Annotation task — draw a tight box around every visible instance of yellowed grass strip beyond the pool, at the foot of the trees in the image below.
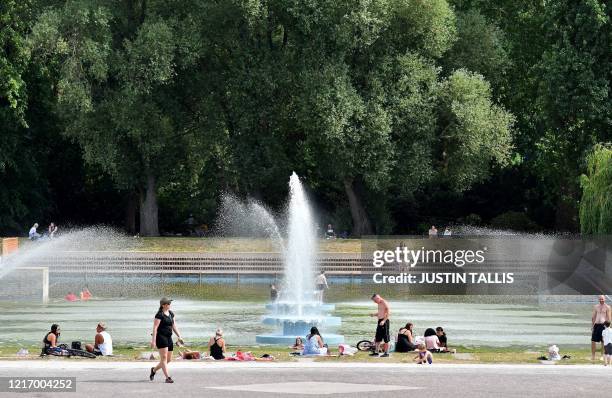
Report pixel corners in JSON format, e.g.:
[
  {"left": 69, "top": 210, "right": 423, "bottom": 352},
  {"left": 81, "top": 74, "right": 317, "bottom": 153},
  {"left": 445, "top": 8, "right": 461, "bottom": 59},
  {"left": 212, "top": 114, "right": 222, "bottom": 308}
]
[{"left": 19, "top": 236, "right": 362, "bottom": 253}]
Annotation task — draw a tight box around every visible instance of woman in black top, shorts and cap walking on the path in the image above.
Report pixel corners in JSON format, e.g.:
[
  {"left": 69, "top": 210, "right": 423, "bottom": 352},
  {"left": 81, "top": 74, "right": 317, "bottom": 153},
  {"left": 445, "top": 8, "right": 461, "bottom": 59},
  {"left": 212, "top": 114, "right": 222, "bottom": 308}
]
[{"left": 149, "top": 297, "right": 183, "bottom": 383}]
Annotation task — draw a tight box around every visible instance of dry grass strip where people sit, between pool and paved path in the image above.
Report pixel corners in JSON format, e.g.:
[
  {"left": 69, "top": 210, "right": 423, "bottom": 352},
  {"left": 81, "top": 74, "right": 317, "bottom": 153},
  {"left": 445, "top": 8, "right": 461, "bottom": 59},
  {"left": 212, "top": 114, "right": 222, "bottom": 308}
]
[{"left": 0, "top": 345, "right": 603, "bottom": 365}]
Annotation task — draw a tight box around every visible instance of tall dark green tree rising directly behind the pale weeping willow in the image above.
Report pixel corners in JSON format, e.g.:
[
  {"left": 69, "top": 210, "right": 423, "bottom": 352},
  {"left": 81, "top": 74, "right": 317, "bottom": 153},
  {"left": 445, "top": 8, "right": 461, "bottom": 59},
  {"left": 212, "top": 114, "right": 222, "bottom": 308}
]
[{"left": 536, "top": 0, "right": 612, "bottom": 230}]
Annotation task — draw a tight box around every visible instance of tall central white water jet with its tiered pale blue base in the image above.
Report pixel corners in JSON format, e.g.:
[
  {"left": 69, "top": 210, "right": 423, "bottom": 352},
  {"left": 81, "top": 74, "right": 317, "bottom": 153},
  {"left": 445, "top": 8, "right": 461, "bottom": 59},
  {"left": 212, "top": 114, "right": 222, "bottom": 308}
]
[{"left": 251, "top": 173, "right": 344, "bottom": 344}]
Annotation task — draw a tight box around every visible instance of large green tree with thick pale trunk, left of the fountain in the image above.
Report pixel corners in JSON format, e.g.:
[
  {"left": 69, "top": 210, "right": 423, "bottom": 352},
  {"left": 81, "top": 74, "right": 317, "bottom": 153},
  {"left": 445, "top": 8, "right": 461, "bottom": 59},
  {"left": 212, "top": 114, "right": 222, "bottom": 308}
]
[{"left": 31, "top": 0, "right": 216, "bottom": 236}]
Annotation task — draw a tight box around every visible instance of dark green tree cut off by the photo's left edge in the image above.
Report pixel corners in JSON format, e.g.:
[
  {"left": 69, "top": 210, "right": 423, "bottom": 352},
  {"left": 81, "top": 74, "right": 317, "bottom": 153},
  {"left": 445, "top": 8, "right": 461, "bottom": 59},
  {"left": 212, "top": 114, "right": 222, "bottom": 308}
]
[{"left": 0, "top": 0, "right": 46, "bottom": 233}]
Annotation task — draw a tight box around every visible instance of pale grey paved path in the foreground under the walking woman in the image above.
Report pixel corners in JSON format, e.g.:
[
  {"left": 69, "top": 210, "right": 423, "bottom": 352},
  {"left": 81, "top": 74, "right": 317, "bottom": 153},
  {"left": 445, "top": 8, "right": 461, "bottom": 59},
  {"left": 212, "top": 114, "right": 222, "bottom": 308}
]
[{"left": 0, "top": 359, "right": 612, "bottom": 398}]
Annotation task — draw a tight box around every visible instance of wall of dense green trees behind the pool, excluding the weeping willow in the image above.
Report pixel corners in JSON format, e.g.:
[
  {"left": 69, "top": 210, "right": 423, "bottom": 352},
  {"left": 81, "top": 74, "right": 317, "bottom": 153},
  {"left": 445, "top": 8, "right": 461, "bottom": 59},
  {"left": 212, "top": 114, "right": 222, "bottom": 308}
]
[{"left": 0, "top": 0, "right": 612, "bottom": 236}]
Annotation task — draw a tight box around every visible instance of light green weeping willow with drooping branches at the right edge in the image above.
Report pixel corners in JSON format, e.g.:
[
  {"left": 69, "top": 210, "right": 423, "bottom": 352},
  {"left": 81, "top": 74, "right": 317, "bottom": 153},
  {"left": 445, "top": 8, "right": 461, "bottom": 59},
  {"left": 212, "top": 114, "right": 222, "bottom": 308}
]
[{"left": 580, "top": 144, "right": 612, "bottom": 235}]
